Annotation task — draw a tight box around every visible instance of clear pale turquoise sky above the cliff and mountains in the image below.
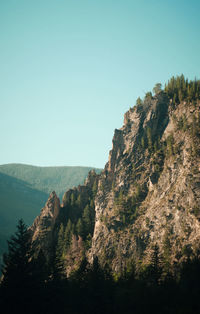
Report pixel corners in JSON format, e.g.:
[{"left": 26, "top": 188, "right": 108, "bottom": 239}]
[{"left": 0, "top": 0, "right": 200, "bottom": 167}]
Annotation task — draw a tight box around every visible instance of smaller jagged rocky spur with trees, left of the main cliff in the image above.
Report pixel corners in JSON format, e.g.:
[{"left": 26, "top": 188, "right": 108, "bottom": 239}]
[{"left": 29, "top": 170, "right": 99, "bottom": 264}]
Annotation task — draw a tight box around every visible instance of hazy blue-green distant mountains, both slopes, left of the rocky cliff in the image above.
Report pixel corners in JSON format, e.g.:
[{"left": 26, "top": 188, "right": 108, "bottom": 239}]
[{"left": 0, "top": 164, "right": 101, "bottom": 268}]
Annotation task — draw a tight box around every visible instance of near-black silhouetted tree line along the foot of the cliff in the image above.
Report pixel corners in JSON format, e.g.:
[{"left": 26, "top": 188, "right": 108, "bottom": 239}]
[{"left": 0, "top": 220, "right": 200, "bottom": 314}]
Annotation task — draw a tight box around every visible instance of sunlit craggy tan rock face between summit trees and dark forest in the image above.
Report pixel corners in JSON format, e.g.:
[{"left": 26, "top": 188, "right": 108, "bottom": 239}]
[{"left": 31, "top": 87, "right": 200, "bottom": 273}]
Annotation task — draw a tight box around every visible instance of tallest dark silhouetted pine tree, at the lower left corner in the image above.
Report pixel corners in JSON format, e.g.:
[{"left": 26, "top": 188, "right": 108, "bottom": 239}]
[{"left": 1, "top": 219, "right": 34, "bottom": 313}]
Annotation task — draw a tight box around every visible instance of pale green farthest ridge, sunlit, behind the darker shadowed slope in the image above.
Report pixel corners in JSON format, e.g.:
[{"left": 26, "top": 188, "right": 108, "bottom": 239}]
[{"left": 0, "top": 164, "right": 101, "bottom": 198}]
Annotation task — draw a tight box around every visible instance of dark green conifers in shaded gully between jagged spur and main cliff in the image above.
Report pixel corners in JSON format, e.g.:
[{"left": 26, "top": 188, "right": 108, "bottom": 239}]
[{"left": 54, "top": 172, "right": 97, "bottom": 272}]
